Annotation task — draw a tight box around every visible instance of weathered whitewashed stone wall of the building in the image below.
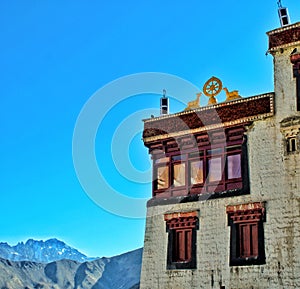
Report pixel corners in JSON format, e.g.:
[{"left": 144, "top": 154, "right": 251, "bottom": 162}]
[{"left": 140, "top": 23, "right": 300, "bottom": 289}]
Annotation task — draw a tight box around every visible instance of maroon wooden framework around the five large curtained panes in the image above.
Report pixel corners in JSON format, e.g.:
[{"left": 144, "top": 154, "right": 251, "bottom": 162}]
[{"left": 153, "top": 141, "right": 243, "bottom": 197}]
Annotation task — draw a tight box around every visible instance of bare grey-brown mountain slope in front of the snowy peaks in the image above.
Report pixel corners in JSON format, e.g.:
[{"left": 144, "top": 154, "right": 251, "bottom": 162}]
[{"left": 0, "top": 238, "right": 142, "bottom": 289}]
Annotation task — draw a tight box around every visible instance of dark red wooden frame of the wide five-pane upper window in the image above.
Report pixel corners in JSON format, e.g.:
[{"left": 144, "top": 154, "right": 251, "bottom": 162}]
[{"left": 153, "top": 141, "right": 248, "bottom": 197}]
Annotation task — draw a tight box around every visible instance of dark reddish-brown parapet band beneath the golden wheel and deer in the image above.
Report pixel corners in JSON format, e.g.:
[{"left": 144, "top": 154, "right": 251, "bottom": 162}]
[{"left": 143, "top": 93, "right": 274, "bottom": 145}]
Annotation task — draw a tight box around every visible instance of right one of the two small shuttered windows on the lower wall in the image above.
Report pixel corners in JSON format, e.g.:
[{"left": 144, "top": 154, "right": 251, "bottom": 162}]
[{"left": 227, "top": 203, "right": 265, "bottom": 266}]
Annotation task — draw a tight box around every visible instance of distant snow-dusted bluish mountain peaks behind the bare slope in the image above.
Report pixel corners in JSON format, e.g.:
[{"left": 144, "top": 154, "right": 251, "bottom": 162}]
[{"left": 0, "top": 239, "right": 95, "bottom": 263}]
